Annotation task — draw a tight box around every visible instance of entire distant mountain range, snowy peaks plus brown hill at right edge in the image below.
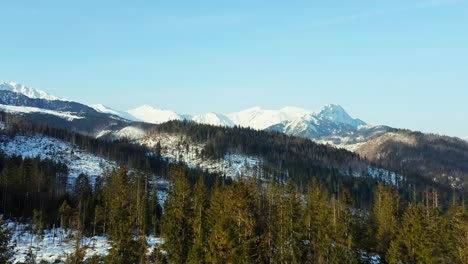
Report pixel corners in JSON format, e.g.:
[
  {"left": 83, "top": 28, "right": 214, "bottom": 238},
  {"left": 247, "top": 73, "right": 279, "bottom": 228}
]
[{"left": 0, "top": 80, "right": 468, "bottom": 189}]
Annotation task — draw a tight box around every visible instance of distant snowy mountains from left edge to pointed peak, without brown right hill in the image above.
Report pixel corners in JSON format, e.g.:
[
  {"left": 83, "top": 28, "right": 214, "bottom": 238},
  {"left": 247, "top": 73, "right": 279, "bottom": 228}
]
[{"left": 0, "top": 82, "right": 387, "bottom": 145}]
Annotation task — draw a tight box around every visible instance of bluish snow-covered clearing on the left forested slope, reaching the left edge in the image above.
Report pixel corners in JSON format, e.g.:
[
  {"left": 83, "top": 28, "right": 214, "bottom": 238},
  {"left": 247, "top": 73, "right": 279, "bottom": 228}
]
[{"left": 0, "top": 135, "right": 116, "bottom": 183}]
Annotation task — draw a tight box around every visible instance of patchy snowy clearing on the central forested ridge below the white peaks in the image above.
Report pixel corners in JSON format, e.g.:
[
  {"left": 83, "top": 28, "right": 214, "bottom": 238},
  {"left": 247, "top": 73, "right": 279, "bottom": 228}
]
[{"left": 138, "top": 134, "right": 261, "bottom": 178}]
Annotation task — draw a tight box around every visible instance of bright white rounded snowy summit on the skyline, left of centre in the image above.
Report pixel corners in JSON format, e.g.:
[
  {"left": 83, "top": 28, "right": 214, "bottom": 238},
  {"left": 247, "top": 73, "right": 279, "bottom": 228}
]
[{"left": 127, "top": 105, "right": 183, "bottom": 124}]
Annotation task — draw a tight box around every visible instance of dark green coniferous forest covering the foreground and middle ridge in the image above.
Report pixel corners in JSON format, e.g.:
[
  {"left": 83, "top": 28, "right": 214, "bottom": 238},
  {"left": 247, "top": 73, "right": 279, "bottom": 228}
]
[{"left": 0, "top": 114, "right": 468, "bottom": 263}]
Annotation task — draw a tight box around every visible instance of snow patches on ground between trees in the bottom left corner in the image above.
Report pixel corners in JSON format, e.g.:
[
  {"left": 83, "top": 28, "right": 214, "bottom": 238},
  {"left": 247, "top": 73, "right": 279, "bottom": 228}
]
[{"left": 8, "top": 222, "right": 164, "bottom": 263}]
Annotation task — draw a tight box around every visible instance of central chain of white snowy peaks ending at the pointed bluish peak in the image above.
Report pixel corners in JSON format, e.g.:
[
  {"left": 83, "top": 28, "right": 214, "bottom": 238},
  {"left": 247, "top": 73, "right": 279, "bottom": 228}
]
[{"left": 88, "top": 101, "right": 387, "bottom": 145}]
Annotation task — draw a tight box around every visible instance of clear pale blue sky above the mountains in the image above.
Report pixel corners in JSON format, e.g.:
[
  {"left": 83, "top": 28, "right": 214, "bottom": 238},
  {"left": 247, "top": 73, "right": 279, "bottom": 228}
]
[{"left": 0, "top": 0, "right": 468, "bottom": 137}]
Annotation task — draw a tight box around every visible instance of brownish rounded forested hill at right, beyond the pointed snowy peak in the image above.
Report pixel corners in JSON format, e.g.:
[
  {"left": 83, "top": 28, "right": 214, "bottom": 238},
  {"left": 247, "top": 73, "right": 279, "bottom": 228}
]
[{"left": 356, "top": 130, "right": 468, "bottom": 192}]
